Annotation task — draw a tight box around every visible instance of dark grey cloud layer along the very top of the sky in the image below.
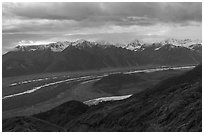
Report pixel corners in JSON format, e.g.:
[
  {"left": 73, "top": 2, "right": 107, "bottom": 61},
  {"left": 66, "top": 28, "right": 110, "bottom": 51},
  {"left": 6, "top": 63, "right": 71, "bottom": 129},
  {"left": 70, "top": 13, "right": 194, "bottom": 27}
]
[{"left": 3, "top": 2, "right": 202, "bottom": 22}]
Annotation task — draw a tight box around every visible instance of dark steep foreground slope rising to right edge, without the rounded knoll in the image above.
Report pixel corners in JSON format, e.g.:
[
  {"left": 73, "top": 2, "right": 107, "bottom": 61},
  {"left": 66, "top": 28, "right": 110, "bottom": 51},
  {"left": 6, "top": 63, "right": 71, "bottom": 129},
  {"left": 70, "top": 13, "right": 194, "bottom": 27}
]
[{"left": 66, "top": 66, "right": 202, "bottom": 131}]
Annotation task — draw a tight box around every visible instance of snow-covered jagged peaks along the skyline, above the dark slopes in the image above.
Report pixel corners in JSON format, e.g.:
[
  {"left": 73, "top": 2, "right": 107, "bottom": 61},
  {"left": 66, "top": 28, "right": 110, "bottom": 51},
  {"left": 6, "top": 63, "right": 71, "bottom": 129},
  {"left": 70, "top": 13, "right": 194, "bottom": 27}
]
[{"left": 12, "top": 38, "right": 202, "bottom": 52}]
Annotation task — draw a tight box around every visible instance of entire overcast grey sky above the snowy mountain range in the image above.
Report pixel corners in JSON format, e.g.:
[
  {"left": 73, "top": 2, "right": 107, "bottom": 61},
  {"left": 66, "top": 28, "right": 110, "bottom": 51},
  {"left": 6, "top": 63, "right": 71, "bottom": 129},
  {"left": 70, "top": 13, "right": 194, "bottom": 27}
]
[{"left": 2, "top": 2, "right": 202, "bottom": 53}]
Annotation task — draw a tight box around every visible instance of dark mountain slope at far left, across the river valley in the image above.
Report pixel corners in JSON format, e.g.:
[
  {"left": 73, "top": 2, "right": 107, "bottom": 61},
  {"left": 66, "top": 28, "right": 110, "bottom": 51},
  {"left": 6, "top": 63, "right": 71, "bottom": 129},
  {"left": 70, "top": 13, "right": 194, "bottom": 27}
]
[{"left": 2, "top": 50, "right": 59, "bottom": 76}]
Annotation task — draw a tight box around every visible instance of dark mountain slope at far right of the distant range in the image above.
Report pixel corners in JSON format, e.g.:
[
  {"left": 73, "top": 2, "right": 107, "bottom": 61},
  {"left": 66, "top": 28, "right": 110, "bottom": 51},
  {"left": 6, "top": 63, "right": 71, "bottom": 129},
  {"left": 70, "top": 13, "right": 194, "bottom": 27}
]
[{"left": 134, "top": 44, "right": 202, "bottom": 65}]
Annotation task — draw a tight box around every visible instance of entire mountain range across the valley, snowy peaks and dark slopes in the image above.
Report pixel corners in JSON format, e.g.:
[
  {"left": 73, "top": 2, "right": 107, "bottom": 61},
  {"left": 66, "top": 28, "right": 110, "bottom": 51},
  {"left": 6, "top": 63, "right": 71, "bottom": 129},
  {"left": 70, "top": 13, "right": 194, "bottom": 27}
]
[{"left": 2, "top": 39, "right": 202, "bottom": 77}]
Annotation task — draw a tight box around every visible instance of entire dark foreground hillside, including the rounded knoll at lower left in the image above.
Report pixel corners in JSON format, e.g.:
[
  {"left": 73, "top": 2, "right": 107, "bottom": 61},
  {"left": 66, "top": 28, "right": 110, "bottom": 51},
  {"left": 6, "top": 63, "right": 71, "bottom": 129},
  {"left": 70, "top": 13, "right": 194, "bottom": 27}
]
[{"left": 3, "top": 65, "right": 202, "bottom": 132}]
